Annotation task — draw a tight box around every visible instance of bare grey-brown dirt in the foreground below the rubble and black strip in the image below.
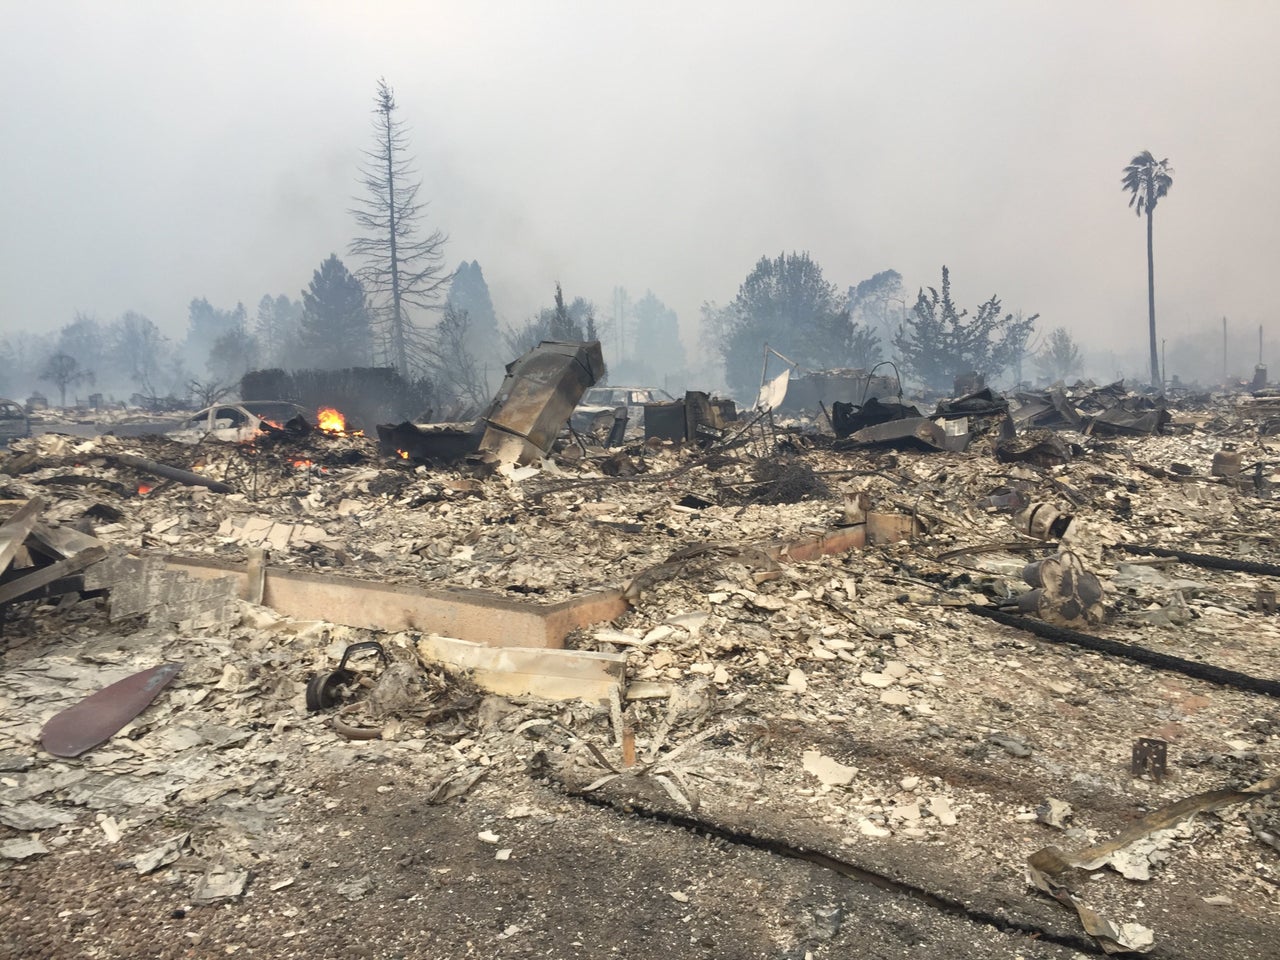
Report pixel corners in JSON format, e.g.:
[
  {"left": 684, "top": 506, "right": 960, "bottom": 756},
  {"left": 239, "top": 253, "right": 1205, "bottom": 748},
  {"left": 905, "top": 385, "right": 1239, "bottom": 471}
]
[{"left": 0, "top": 763, "right": 1083, "bottom": 960}]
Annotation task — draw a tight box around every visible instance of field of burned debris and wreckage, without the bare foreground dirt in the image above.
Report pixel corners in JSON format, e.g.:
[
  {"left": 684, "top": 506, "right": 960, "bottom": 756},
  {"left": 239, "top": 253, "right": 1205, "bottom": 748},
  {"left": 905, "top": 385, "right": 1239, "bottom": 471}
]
[{"left": 0, "top": 343, "right": 1280, "bottom": 955}]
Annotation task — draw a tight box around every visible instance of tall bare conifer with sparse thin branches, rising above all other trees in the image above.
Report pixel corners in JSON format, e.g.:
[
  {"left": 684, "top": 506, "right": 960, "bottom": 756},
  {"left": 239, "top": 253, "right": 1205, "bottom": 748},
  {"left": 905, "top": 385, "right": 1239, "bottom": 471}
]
[{"left": 351, "top": 79, "right": 451, "bottom": 379}]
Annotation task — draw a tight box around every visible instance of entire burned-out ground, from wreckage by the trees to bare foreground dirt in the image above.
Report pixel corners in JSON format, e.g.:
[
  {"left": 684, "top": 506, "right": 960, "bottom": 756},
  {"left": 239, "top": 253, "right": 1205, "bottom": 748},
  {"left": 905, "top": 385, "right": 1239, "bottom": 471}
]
[{"left": 0, "top": 342, "right": 1280, "bottom": 957}]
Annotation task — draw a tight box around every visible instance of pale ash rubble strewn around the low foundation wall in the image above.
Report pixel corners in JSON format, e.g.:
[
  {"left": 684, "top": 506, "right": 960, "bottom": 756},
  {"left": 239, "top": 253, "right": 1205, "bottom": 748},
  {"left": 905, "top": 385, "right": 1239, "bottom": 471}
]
[{"left": 0, "top": 389, "right": 1280, "bottom": 957}]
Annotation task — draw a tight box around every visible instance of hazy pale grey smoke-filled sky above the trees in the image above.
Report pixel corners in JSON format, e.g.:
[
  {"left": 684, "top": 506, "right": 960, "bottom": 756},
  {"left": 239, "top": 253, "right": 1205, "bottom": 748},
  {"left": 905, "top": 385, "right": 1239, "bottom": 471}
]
[{"left": 0, "top": 0, "right": 1280, "bottom": 371}]
